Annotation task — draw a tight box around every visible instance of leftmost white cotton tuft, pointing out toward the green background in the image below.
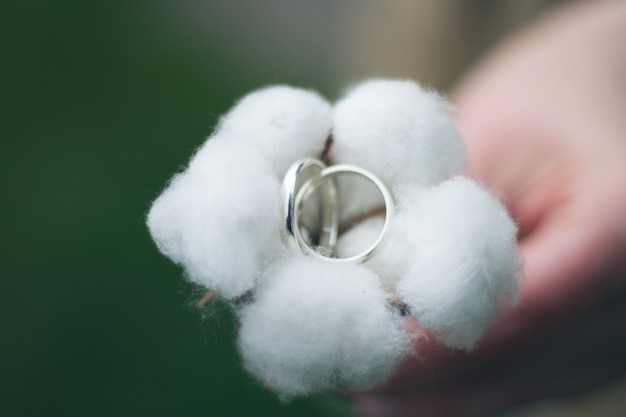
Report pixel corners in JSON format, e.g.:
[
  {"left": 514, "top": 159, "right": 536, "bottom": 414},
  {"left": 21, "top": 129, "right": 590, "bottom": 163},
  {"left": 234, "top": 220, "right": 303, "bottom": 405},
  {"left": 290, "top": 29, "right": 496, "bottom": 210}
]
[{"left": 148, "top": 140, "right": 281, "bottom": 298}]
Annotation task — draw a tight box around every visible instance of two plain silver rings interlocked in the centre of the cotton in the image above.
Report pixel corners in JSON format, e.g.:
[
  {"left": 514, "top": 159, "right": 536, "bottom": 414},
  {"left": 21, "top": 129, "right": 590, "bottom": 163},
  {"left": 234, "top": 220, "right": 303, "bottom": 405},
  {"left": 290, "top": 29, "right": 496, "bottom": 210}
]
[{"left": 280, "top": 158, "right": 394, "bottom": 263}]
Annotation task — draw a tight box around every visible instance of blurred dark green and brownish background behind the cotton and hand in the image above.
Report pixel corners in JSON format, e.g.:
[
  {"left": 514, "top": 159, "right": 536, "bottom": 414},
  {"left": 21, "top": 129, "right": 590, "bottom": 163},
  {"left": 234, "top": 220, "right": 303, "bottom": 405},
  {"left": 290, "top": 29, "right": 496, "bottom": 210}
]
[{"left": 6, "top": 0, "right": 624, "bottom": 417}]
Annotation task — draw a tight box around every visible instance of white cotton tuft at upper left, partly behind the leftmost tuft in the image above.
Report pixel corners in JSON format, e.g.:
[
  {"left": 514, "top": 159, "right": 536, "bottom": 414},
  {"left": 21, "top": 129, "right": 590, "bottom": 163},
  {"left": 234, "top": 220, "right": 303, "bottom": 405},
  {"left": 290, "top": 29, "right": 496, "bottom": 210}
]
[{"left": 216, "top": 86, "right": 332, "bottom": 179}]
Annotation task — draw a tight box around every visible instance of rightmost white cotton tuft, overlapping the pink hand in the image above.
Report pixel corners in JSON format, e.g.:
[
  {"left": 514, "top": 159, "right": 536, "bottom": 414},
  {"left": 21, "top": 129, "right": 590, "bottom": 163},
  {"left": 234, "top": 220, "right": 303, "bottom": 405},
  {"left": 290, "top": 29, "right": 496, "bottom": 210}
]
[{"left": 397, "top": 177, "right": 521, "bottom": 349}]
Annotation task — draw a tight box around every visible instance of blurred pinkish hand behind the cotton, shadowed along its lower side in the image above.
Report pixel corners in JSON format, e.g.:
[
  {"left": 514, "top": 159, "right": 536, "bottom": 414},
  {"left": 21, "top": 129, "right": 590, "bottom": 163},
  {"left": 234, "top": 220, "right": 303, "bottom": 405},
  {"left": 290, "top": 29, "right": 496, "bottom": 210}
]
[{"left": 358, "top": 1, "right": 626, "bottom": 417}]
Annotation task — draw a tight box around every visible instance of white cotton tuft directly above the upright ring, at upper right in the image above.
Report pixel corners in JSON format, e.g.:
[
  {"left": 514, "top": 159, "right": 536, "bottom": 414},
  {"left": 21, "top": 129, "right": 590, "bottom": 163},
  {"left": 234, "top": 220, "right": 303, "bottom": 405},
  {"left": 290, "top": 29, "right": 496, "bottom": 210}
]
[{"left": 332, "top": 80, "right": 466, "bottom": 186}]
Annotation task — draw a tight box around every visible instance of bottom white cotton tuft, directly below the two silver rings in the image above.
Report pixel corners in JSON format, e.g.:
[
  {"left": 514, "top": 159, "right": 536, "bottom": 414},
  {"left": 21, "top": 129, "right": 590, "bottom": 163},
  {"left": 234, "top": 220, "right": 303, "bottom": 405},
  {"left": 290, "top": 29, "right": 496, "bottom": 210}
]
[{"left": 239, "top": 256, "right": 410, "bottom": 398}]
